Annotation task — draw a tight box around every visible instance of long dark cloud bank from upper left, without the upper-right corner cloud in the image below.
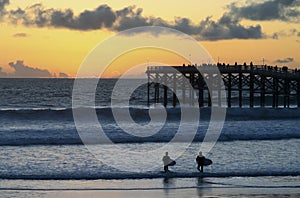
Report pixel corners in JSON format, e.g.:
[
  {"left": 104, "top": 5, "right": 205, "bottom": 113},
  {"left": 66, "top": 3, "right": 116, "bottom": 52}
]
[{"left": 1, "top": 4, "right": 263, "bottom": 41}]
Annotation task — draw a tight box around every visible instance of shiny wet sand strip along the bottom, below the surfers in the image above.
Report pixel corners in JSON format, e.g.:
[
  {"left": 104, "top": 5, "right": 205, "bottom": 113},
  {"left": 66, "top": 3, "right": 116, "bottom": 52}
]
[{"left": 0, "top": 176, "right": 300, "bottom": 198}]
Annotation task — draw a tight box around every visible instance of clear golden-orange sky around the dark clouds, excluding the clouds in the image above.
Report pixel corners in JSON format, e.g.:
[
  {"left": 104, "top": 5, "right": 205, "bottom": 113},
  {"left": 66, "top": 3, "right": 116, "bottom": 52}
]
[{"left": 0, "top": 0, "right": 300, "bottom": 77}]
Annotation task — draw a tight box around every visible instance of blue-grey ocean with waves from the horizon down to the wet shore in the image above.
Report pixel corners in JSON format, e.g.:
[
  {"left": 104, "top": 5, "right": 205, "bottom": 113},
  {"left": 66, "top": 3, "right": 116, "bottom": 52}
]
[{"left": 0, "top": 79, "right": 300, "bottom": 197}]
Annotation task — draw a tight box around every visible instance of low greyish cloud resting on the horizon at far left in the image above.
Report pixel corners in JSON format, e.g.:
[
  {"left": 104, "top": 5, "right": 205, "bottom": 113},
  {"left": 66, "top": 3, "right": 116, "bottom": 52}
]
[{"left": 7, "top": 60, "right": 52, "bottom": 78}]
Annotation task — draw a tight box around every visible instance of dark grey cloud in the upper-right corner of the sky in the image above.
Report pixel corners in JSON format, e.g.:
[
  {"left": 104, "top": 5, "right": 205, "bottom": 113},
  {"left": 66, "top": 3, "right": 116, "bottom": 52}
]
[{"left": 228, "top": 0, "right": 300, "bottom": 23}]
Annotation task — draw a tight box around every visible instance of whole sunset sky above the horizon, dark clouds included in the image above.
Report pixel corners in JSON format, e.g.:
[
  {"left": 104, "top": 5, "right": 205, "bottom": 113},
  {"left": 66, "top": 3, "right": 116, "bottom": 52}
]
[{"left": 0, "top": 0, "right": 300, "bottom": 77}]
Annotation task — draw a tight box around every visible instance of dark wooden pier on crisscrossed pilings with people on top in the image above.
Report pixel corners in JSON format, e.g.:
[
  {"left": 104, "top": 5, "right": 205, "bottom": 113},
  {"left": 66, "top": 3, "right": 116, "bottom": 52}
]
[{"left": 146, "top": 63, "right": 300, "bottom": 108}]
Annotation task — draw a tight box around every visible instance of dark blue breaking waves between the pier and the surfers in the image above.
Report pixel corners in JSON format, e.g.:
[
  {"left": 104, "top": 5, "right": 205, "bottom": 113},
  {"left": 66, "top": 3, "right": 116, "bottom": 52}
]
[{"left": 0, "top": 107, "right": 300, "bottom": 146}]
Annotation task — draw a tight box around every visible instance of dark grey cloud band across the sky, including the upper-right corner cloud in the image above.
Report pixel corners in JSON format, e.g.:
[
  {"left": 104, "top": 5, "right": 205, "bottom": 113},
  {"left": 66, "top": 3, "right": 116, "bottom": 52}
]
[{"left": 0, "top": 0, "right": 300, "bottom": 41}]
